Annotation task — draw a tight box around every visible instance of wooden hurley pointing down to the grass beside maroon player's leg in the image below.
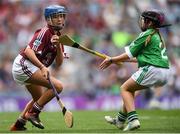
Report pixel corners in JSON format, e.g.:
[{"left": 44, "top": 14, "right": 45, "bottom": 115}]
[{"left": 48, "top": 74, "right": 73, "bottom": 128}]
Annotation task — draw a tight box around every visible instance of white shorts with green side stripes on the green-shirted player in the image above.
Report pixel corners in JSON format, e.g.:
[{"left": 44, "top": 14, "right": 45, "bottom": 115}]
[{"left": 131, "top": 66, "right": 170, "bottom": 87}]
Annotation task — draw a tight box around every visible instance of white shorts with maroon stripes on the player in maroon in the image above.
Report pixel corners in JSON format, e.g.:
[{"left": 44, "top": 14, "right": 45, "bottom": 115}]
[{"left": 12, "top": 54, "right": 39, "bottom": 85}]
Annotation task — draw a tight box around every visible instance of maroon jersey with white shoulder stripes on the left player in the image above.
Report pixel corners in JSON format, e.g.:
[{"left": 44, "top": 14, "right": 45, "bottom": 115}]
[{"left": 20, "top": 26, "right": 60, "bottom": 67}]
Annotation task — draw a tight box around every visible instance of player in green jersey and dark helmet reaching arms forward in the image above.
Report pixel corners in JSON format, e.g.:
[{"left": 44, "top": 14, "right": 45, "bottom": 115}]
[{"left": 99, "top": 10, "right": 170, "bottom": 131}]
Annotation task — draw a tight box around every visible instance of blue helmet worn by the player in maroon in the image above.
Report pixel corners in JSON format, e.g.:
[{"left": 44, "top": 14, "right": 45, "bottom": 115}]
[{"left": 44, "top": 5, "right": 68, "bottom": 30}]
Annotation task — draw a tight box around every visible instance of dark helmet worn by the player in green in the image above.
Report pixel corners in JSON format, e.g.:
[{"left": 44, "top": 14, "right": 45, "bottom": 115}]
[{"left": 141, "top": 10, "right": 171, "bottom": 28}]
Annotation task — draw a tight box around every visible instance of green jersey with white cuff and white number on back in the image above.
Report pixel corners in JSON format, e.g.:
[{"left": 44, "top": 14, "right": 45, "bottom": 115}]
[{"left": 125, "top": 29, "right": 169, "bottom": 68}]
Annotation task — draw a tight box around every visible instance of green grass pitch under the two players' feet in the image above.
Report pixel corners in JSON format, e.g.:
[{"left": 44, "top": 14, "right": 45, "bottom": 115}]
[{"left": 0, "top": 110, "right": 180, "bottom": 133}]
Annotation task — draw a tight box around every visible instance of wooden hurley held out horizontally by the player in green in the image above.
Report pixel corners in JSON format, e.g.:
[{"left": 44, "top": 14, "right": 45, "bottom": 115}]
[{"left": 59, "top": 35, "right": 122, "bottom": 65}]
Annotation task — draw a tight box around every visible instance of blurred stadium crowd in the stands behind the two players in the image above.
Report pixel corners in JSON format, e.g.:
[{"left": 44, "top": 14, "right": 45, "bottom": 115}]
[{"left": 0, "top": 0, "right": 180, "bottom": 112}]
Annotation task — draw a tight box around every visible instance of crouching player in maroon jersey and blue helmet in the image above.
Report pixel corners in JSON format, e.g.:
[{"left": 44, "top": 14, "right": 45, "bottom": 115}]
[{"left": 10, "top": 5, "right": 67, "bottom": 131}]
